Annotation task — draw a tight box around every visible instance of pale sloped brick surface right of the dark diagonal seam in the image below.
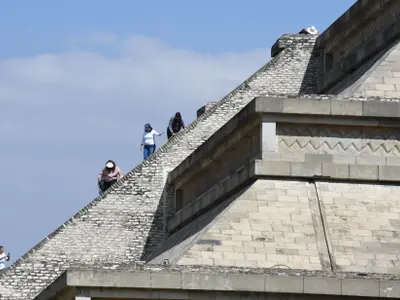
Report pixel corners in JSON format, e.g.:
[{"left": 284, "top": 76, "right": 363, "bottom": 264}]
[{"left": 317, "top": 182, "right": 400, "bottom": 273}]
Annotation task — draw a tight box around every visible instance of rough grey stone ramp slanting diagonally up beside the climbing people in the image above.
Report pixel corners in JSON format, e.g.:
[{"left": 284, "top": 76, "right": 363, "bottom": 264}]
[{"left": 0, "top": 39, "right": 318, "bottom": 300}]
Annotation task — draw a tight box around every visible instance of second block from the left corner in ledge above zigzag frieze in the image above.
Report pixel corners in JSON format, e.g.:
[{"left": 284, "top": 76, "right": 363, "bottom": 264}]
[{"left": 282, "top": 98, "right": 331, "bottom": 115}]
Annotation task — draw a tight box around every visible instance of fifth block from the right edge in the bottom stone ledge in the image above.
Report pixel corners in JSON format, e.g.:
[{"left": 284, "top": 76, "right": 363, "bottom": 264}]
[{"left": 226, "top": 274, "right": 265, "bottom": 292}]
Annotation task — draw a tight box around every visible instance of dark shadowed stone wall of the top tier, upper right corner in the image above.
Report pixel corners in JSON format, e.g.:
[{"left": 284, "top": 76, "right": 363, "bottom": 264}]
[{"left": 316, "top": 0, "right": 400, "bottom": 93}]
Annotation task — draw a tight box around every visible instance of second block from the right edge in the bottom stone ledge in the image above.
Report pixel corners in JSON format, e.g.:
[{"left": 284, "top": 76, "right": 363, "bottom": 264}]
[{"left": 342, "top": 279, "right": 379, "bottom": 297}]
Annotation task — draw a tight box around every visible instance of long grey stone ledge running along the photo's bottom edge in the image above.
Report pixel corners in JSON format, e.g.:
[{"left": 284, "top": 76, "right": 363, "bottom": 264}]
[{"left": 36, "top": 269, "right": 400, "bottom": 300}]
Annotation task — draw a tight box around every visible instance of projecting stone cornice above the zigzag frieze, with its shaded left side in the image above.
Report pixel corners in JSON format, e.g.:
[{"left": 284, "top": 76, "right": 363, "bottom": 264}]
[{"left": 168, "top": 96, "right": 400, "bottom": 189}]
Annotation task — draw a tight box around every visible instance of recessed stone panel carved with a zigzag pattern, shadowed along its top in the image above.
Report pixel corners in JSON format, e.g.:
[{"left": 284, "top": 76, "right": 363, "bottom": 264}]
[{"left": 276, "top": 123, "right": 400, "bottom": 165}]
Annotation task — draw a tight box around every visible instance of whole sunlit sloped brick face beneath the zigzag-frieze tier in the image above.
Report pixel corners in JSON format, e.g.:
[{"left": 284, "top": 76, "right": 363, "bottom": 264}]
[{"left": 151, "top": 179, "right": 400, "bottom": 273}]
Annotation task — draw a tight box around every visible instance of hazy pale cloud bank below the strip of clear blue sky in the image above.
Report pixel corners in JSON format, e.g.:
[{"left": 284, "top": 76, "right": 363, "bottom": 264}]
[{"left": 0, "top": 33, "right": 269, "bottom": 257}]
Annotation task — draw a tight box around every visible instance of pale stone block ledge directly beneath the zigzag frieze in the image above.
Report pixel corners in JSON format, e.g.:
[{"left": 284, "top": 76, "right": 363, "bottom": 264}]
[{"left": 254, "top": 160, "right": 400, "bottom": 182}]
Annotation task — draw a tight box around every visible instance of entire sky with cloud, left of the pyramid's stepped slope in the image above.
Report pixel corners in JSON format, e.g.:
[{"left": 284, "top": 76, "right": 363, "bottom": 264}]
[{"left": 0, "top": 0, "right": 355, "bottom": 260}]
